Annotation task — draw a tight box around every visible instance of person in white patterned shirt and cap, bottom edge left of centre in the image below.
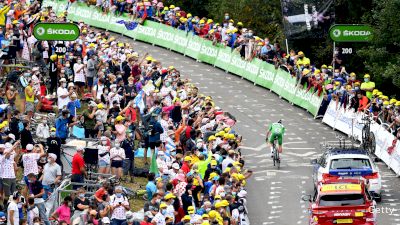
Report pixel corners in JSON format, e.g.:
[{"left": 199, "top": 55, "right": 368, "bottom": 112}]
[{"left": 110, "top": 186, "right": 130, "bottom": 225}]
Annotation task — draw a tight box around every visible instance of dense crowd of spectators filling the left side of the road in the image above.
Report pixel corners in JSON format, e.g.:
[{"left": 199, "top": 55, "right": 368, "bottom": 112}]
[{"left": 0, "top": 1, "right": 252, "bottom": 225}]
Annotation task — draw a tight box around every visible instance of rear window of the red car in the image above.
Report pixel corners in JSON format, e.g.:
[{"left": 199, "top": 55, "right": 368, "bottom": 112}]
[{"left": 319, "top": 194, "right": 365, "bottom": 206}]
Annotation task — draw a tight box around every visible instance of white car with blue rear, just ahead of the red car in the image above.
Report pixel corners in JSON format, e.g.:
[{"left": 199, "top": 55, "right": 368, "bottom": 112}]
[{"left": 311, "top": 149, "right": 382, "bottom": 202}]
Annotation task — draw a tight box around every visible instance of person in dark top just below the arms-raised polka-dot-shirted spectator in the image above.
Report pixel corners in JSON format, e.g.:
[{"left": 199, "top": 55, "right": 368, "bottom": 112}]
[{"left": 26, "top": 173, "right": 50, "bottom": 225}]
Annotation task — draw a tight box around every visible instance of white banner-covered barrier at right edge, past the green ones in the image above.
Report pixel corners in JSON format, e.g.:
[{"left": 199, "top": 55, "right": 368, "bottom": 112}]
[{"left": 322, "top": 101, "right": 400, "bottom": 175}]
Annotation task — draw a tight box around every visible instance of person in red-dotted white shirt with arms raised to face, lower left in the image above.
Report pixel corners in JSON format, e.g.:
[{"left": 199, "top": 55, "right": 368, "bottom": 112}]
[{"left": 22, "top": 144, "right": 46, "bottom": 185}]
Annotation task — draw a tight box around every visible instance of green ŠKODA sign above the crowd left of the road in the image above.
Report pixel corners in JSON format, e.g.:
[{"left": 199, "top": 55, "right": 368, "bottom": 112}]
[{"left": 33, "top": 23, "right": 80, "bottom": 41}]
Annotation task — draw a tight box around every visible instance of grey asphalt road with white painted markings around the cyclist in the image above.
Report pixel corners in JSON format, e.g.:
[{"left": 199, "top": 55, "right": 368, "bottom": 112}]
[{"left": 110, "top": 32, "right": 400, "bottom": 225}]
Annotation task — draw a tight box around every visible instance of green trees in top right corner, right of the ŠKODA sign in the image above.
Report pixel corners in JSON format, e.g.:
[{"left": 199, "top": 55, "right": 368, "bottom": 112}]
[{"left": 358, "top": 0, "right": 400, "bottom": 97}]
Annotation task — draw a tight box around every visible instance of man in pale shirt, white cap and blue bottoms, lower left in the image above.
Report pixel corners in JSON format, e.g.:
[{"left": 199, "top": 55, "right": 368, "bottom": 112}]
[{"left": 42, "top": 153, "right": 62, "bottom": 200}]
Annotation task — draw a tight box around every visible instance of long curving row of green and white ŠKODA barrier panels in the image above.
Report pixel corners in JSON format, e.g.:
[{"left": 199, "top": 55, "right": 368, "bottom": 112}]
[{"left": 43, "top": 0, "right": 322, "bottom": 116}]
